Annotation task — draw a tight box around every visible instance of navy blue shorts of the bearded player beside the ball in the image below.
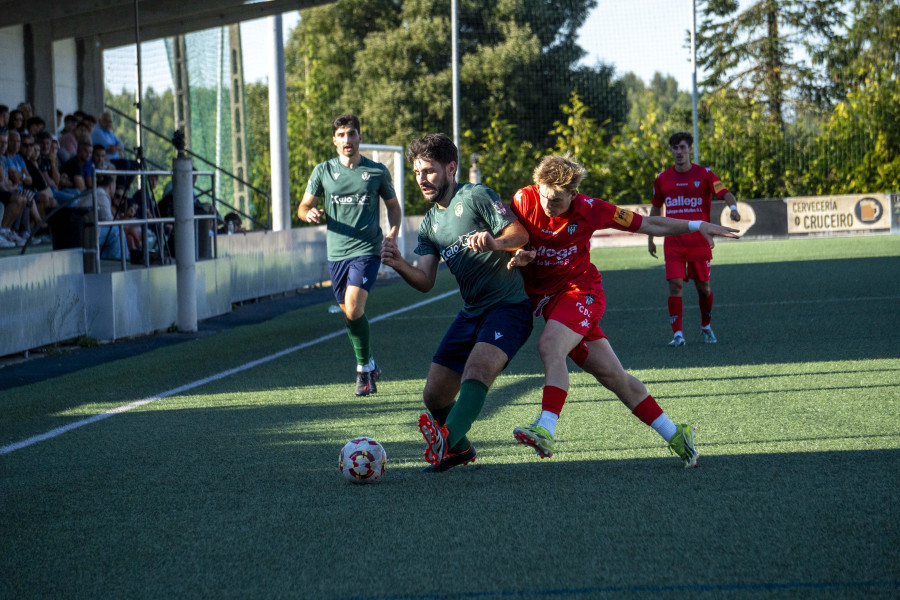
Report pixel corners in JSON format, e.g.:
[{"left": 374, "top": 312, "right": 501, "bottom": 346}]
[{"left": 432, "top": 300, "right": 534, "bottom": 373}]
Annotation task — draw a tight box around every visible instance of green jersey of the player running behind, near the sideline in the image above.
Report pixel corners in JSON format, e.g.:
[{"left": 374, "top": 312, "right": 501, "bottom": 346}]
[{"left": 306, "top": 156, "right": 396, "bottom": 261}]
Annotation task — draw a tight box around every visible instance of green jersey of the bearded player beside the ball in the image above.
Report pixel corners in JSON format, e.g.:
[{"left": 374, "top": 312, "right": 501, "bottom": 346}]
[{"left": 416, "top": 183, "right": 527, "bottom": 315}]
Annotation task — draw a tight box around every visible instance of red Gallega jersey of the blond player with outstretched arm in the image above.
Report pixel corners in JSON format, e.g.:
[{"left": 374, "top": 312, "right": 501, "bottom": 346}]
[{"left": 512, "top": 185, "right": 643, "bottom": 297}]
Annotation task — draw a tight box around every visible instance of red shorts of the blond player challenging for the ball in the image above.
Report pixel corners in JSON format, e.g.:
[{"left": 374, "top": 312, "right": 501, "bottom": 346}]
[{"left": 531, "top": 289, "right": 606, "bottom": 367}]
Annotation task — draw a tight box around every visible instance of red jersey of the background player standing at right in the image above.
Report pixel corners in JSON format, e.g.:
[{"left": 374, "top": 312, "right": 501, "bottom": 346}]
[{"left": 651, "top": 164, "right": 728, "bottom": 261}]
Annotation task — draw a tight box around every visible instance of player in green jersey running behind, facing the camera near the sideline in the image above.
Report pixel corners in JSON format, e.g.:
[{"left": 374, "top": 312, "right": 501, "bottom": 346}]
[{"left": 297, "top": 114, "right": 401, "bottom": 396}]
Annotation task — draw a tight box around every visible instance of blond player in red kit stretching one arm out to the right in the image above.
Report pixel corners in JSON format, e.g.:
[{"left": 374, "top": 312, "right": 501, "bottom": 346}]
[{"left": 509, "top": 156, "right": 736, "bottom": 467}]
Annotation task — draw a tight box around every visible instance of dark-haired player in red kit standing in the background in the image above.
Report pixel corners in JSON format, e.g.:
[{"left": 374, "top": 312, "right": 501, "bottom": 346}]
[{"left": 647, "top": 131, "right": 741, "bottom": 346}]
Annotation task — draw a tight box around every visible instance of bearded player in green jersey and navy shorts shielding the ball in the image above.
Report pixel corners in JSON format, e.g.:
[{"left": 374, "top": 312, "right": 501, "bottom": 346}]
[{"left": 381, "top": 133, "right": 533, "bottom": 473}]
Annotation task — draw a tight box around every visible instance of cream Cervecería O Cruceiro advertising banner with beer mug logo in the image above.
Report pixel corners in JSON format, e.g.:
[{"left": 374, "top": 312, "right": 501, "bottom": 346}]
[{"left": 784, "top": 194, "right": 891, "bottom": 234}]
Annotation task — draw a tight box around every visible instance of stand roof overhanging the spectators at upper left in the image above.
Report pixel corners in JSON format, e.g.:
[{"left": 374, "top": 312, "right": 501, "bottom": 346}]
[{"left": 0, "top": 0, "right": 334, "bottom": 48}]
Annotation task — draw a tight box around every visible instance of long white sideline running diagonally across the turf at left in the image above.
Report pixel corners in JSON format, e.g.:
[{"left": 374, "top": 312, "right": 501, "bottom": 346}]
[{"left": 0, "top": 290, "right": 459, "bottom": 455}]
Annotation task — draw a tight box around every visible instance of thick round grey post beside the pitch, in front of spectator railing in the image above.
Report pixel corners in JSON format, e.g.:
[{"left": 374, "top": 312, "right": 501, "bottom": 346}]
[{"left": 172, "top": 153, "right": 197, "bottom": 333}]
